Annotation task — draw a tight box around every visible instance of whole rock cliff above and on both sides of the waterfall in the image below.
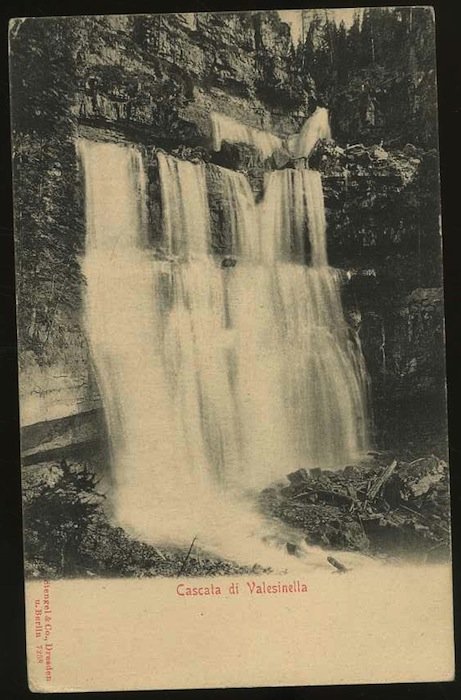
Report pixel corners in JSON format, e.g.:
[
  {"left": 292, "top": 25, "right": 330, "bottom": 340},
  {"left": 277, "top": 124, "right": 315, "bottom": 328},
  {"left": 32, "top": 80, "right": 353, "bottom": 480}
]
[{"left": 11, "top": 12, "right": 444, "bottom": 456}]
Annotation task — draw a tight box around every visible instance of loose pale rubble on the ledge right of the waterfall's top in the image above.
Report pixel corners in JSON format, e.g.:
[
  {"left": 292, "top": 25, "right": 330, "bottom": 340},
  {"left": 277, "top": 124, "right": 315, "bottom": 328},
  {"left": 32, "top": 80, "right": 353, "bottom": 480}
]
[{"left": 309, "top": 140, "right": 424, "bottom": 185}]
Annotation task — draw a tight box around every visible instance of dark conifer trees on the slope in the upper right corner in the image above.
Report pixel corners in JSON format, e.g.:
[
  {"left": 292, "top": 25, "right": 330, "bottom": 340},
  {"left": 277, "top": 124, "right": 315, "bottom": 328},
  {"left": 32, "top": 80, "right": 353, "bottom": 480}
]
[{"left": 297, "top": 7, "right": 437, "bottom": 148}]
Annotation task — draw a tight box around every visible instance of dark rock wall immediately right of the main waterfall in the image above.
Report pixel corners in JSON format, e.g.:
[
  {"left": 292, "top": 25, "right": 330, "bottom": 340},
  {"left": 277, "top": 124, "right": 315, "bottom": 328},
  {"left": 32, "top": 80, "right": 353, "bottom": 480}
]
[{"left": 311, "top": 144, "right": 446, "bottom": 447}]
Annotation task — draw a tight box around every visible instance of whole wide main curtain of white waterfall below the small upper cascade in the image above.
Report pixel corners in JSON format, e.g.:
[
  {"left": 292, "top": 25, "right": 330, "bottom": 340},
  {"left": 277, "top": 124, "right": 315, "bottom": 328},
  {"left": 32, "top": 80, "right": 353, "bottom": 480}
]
[{"left": 78, "top": 139, "right": 366, "bottom": 542}]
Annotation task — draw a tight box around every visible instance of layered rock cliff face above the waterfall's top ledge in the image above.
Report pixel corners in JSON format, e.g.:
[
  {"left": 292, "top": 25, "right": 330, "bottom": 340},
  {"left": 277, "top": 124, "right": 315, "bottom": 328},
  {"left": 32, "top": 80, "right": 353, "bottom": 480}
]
[{"left": 75, "top": 12, "right": 308, "bottom": 145}]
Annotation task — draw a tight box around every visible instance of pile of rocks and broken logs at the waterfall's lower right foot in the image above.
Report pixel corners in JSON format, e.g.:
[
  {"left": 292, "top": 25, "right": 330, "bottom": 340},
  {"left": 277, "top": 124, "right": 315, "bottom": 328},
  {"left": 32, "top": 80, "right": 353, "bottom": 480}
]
[{"left": 260, "top": 453, "right": 450, "bottom": 561}]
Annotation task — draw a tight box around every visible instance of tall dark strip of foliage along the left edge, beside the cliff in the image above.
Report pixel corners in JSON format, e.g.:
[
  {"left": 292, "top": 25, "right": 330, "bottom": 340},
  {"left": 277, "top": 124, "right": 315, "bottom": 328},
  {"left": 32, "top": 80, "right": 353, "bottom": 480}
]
[{"left": 10, "top": 18, "right": 83, "bottom": 357}]
